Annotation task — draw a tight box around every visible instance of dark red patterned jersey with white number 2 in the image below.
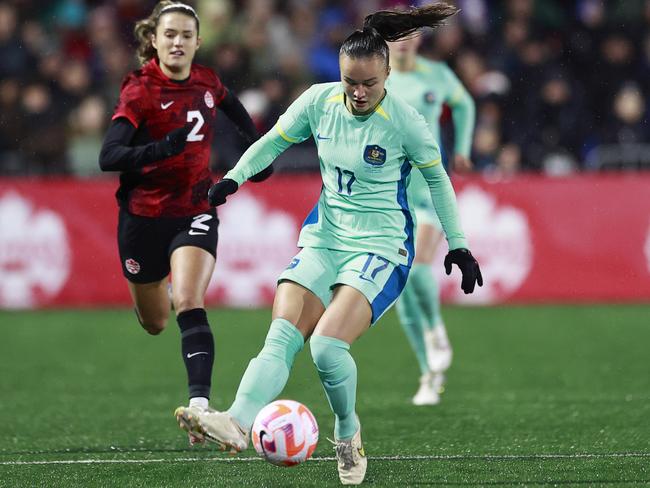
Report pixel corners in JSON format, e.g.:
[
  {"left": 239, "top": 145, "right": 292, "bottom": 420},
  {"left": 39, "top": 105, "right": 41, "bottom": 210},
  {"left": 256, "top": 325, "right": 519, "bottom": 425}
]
[{"left": 113, "top": 59, "right": 226, "bottom": 217}]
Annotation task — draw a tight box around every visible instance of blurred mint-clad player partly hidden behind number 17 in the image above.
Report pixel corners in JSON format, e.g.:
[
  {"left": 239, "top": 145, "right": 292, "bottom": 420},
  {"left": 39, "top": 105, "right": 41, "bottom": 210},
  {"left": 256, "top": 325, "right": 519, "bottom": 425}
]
[{"left": 386, "top": 23, "right": 476, "bottom": 405}]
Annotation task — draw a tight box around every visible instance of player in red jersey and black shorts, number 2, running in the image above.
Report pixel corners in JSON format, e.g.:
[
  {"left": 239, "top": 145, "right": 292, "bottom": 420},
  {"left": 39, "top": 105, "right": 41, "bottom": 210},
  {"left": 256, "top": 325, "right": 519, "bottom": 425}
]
[{"left": 99, "top": 1, "right": 272, "bottom": 443}]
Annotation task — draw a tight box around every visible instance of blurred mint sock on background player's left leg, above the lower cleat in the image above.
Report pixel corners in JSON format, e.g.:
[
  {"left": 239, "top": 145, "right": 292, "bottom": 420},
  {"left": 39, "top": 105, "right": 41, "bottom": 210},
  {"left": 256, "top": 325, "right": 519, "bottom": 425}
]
[{"left": 395, "top": 276, "right": 429, "bottom": 374}]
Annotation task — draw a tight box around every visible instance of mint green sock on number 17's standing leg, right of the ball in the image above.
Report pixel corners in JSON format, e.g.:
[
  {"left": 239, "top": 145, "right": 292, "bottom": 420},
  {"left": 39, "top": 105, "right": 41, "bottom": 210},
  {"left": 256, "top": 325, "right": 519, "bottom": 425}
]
[{"left": 309, "top": 335, "right": 359, "bottom": 440}]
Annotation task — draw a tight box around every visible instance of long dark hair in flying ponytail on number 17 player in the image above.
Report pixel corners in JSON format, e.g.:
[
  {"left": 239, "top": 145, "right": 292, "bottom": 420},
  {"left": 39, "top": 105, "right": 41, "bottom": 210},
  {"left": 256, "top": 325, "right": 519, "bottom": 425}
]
[{"left": 339, "top": 2, "right": 458, "bottom": 65}]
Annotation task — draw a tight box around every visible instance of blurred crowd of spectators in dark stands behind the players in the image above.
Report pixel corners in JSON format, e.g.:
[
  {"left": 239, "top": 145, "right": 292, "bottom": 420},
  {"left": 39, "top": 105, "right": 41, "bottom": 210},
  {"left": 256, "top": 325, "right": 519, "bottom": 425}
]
[{"left": 0, "top": 0, "right": 650, "bottom": 176}]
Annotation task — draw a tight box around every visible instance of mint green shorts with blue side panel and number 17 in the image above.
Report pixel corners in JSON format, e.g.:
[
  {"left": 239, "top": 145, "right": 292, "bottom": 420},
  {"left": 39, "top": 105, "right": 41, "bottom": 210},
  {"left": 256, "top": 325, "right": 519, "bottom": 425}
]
[{"left": 278, "top": 247, "right": 410, "bottom": 324}]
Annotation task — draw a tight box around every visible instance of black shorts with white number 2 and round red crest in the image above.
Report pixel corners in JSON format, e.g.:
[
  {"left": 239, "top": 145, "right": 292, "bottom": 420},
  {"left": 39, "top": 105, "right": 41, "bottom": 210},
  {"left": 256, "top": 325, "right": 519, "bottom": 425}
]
[{"left": 117, "top": 209, "right": 219, "bottom": 283}]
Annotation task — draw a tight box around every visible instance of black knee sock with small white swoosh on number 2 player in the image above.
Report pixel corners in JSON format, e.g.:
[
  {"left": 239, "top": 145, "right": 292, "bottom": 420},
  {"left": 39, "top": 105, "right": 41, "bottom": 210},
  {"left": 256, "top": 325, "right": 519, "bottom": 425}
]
[{"left": 176, "top": 308, "right": 214, "bottom": 398}]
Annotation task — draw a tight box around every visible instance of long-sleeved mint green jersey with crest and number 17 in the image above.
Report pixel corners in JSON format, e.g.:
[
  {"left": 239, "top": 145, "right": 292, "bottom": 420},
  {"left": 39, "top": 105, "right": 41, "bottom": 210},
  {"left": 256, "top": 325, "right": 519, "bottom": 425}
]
[{"left": 225, "top": 82, "right": 466, "bottom": 265}]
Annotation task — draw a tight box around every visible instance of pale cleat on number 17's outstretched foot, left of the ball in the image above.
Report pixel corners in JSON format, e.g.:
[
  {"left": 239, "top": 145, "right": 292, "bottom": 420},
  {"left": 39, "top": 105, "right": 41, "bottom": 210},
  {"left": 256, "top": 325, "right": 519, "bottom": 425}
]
[{"left": 175, "top": 407, "right": 248, "bottom": 452}]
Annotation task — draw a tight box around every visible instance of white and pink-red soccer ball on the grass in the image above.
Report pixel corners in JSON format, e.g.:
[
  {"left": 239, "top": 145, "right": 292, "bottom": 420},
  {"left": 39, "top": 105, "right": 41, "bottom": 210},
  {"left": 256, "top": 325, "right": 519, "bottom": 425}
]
[{"left": 252, "top": 400, "right": 318, "bottom": 466}]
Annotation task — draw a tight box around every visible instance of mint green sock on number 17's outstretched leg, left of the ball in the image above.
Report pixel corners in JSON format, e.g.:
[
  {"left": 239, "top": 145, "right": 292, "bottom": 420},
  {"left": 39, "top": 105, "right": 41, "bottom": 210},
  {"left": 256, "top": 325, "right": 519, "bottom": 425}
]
[{"left": 228, "top": 319, "right": 305, "bottom": 430}]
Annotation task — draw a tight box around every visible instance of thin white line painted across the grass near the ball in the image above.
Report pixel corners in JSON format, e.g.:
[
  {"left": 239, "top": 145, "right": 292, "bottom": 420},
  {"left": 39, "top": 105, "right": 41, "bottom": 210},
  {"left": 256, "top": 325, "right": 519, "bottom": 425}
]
[{"left": 0, "top": 452, "right": 650, "bottom": 466}]
